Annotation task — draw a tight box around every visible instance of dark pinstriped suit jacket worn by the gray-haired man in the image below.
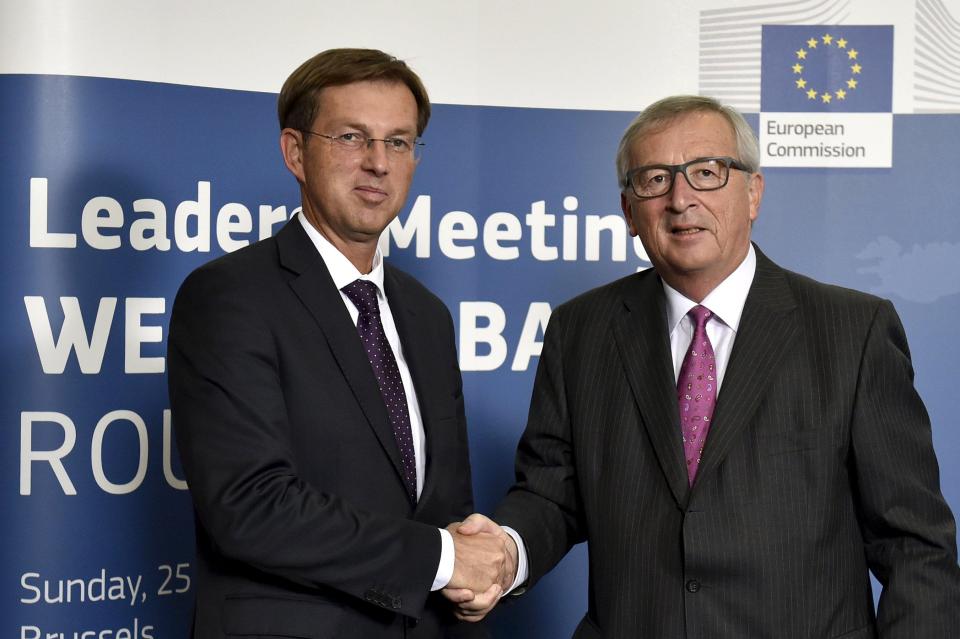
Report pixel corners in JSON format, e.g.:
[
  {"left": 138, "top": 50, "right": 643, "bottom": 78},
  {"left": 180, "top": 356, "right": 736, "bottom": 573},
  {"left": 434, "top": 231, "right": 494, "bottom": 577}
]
[{"left": 495, "top": 246, "right": 960, "bottom": 639}]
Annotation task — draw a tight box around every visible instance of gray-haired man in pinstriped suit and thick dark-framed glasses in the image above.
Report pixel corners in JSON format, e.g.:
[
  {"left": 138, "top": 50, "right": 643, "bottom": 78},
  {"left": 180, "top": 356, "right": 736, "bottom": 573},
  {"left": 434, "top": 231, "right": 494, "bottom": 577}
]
[{"left": 448, "top": 96, "right": 960, "bottom": 639}]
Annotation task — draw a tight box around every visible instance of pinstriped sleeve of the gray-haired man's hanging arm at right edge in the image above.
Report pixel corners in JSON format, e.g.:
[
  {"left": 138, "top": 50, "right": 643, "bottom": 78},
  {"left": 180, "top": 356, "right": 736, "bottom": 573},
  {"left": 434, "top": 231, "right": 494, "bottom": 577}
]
[{"left": 852, "top": 301, "right": 960, "bottom": 639}]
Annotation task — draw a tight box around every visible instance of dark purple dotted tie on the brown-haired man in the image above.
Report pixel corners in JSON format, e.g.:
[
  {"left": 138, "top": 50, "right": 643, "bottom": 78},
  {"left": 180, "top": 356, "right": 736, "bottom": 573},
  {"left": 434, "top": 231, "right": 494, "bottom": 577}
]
[{"left": 340, "top": 280, "right": 417, "bottom": 504}]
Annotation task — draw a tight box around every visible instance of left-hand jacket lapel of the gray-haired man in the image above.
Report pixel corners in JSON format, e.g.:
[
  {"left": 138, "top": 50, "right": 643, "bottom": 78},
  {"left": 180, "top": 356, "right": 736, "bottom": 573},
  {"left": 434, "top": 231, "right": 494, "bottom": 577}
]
[{"left": 613, "top": 270, "right": 688, "bottom": 505}]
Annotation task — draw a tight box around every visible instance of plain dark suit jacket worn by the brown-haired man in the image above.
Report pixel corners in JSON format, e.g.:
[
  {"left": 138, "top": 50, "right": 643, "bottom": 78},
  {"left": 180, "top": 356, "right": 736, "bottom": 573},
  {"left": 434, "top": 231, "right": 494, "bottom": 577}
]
[{"left": 169, "top": 220, "right": 484, "bottom": 639}]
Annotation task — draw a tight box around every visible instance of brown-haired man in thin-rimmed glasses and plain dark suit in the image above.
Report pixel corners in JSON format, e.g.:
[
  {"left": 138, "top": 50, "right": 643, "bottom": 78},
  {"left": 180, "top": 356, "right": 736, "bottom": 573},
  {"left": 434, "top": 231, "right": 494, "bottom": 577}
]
[{"left": 169, "top": 49, "right": 505, "bottom": 639}]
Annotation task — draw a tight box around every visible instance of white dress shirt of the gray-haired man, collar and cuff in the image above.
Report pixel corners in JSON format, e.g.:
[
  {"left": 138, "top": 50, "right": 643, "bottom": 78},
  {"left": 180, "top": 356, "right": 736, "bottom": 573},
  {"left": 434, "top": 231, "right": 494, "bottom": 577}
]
[{"left": 504, "top": 244, "right": 757, "bottom": 592}]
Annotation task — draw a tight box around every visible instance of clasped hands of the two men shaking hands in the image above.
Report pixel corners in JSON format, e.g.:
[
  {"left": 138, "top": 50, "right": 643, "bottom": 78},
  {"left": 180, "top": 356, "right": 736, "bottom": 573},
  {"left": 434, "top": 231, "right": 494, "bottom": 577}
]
[{"left": 443, "top": 514, "right": 519, "bottom": 621}]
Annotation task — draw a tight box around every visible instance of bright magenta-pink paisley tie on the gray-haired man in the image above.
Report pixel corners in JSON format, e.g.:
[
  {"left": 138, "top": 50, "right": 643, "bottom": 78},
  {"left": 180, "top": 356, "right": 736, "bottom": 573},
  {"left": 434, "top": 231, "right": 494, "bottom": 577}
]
[{"left": 677, "top": 305, "right": 717, "bottom": 486}]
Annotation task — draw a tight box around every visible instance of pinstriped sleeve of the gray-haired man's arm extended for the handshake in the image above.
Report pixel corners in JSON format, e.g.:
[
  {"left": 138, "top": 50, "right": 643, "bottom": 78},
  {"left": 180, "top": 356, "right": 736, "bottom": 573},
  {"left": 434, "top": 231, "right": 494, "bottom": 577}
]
[{"left": 494, "top": 307, "right": 586, "bottom": 587}]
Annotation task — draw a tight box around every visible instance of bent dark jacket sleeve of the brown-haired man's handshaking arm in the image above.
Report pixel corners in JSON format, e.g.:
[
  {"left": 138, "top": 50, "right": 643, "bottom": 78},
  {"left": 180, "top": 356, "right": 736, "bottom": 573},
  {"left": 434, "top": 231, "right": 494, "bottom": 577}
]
[{"left": 168, "top": 268, "right": 441, "bottom": 616}]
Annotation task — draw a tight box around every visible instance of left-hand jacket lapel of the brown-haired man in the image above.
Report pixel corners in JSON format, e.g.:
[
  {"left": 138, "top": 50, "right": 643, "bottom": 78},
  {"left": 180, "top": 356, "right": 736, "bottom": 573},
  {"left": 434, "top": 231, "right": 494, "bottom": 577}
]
[{"left": 276, "top": 219, "right": 403, "bottom": 490}]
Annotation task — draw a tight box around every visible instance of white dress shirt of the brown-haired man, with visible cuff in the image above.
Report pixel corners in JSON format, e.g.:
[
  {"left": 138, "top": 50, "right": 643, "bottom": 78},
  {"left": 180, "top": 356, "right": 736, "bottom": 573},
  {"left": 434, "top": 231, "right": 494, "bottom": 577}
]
[{"left": 299, "top": 213, "right": 454, "bottom": 590}]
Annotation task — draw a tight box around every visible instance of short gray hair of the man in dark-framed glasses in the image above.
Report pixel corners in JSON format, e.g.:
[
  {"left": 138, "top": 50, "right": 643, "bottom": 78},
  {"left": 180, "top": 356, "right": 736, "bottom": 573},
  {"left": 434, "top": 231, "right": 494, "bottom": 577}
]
[{"left": 617, "top": 95, "right": 760, "bottom": 189}]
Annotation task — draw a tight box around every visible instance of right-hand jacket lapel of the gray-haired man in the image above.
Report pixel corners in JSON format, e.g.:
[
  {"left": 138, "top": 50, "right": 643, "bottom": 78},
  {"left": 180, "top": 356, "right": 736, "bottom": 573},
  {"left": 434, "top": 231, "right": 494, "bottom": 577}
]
[{"left": 697, "top": 247, "right": 800, "bottom": 483}]
